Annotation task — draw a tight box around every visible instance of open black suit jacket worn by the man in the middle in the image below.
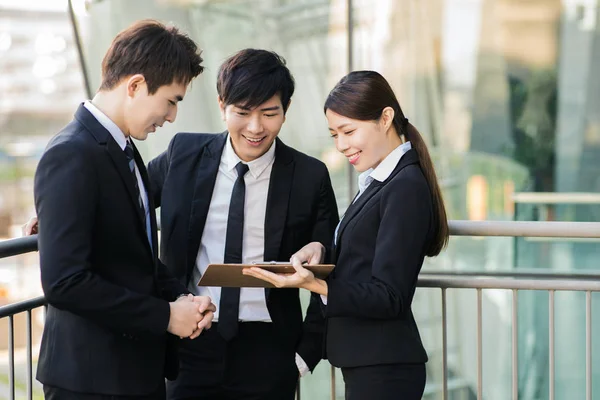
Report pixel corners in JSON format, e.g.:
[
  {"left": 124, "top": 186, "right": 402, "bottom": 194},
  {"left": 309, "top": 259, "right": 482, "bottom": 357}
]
[{"left": 148, "top": 133, "right": 338, "bottom": 370}]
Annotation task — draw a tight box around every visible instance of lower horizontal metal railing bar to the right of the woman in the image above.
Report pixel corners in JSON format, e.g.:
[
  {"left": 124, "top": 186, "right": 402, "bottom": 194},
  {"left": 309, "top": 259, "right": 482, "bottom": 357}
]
[{"left": 417, "top": 274, "right": 600, "bottom": 292}]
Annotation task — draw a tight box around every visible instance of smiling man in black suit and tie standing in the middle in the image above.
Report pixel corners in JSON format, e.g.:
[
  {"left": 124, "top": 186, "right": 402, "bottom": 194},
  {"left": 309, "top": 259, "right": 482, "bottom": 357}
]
[{"left": 148, "top": 49, "right": 338, "bottom": 400}]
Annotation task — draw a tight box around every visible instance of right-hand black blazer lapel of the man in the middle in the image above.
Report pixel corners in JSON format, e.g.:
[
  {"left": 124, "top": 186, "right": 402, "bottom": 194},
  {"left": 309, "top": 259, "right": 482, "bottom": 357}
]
[{"left": 264, "top": 139, "right": 294, "bottom": 298}]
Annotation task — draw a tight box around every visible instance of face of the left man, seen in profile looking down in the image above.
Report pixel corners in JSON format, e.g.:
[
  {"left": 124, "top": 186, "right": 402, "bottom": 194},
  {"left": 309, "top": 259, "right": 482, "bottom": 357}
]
[{"left": 124, "top": 75, "right": 187, "bottom": 140}]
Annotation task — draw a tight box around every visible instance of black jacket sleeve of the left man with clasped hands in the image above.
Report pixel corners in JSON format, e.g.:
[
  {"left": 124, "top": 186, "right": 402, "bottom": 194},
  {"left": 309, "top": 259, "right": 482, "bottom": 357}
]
[{"left": 34, "top": 143, "right": 170, "bottom": 335}]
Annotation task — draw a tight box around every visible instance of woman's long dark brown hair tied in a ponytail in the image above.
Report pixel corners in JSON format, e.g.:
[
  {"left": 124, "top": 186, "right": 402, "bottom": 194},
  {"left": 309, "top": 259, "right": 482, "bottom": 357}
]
[{"left": 324, "top": 71, "right": 449, "bottom": 257}]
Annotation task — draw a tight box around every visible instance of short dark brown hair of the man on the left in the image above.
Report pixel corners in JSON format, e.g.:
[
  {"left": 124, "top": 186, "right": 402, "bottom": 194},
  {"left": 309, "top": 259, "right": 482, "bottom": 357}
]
[{"left": 100, "top": 20, "right": 204, "bottom": 94}]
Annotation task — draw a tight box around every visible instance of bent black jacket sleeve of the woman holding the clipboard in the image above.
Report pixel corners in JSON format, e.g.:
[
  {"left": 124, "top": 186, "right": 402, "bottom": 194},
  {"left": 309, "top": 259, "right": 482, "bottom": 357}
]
[{"left": 326, "top": 175, "right": 432, "bottom": 319}]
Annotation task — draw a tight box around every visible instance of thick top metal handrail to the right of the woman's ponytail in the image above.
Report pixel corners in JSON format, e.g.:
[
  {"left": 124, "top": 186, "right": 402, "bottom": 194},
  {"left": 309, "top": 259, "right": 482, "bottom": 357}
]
[{"left": 448, "top": 220, "right": 600, "bottom": 238}]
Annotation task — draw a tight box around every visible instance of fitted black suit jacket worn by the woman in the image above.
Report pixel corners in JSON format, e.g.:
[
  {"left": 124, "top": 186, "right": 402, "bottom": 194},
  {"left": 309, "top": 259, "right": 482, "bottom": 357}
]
[{"left": 324, "top": 150, "right": 435, "bottom": 367}]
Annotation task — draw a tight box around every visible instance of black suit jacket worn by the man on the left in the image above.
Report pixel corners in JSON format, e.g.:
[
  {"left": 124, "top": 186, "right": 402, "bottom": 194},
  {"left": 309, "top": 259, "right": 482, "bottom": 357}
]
[{"left": 34, "top": 106, "right": 185, "bottom": 395}]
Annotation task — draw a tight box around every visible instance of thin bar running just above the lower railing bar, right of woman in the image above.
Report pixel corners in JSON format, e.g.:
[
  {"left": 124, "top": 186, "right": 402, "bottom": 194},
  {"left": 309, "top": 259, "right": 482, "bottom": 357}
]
[{"left": 419, "top": 268, "right": 600, "bottom": 280}]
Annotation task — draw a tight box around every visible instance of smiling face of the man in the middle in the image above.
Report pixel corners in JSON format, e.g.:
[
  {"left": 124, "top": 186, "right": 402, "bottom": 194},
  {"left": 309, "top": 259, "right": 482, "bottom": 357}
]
[{"left": 219, "top": 94, "right": 285, "bottom": 162}]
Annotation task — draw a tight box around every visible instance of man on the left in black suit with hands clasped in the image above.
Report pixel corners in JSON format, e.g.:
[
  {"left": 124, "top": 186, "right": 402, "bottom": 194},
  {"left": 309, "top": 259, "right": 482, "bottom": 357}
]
[{"left": 34, "top": 21, "right": 214, "bottom": 400}]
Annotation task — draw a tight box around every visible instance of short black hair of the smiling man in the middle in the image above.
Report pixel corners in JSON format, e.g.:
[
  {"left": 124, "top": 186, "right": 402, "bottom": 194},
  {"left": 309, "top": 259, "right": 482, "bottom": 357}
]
[{"left": 217, "top": 49, "right": 294, "bottom": 113}]
